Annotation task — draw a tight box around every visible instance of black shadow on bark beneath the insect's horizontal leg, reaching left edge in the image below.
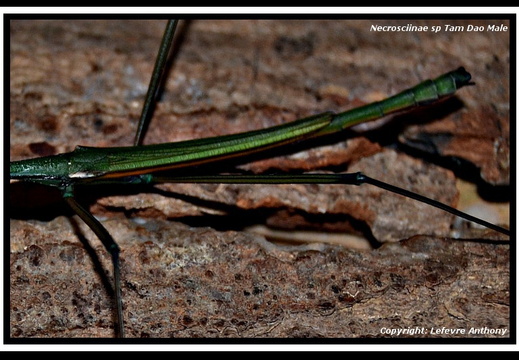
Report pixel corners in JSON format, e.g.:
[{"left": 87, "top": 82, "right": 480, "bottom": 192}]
[{"left": 10, "top": 174, "right": 380, "bottom": 250}]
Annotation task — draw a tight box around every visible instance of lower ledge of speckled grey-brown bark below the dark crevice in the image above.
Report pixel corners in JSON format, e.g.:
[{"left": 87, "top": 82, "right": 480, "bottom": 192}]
[{"left": 10, "top": 218, "right": 510, "bottom": 339}]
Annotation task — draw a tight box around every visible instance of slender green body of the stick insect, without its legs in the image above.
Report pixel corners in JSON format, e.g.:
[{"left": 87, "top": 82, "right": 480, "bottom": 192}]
[{"left": 10, "top": 68, "right": 471, "bottom": 189}]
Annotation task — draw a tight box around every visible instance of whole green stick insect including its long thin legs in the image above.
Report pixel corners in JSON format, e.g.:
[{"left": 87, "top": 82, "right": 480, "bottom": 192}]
[{"left": 10, "top": 19, "right": 510, "bottom": 336}]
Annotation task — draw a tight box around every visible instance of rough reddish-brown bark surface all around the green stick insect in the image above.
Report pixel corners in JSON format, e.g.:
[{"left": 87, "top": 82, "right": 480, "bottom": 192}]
[{"left": 9, "top": 20, "right": 510, "bottom": 337}]
